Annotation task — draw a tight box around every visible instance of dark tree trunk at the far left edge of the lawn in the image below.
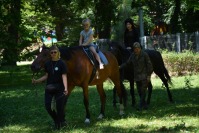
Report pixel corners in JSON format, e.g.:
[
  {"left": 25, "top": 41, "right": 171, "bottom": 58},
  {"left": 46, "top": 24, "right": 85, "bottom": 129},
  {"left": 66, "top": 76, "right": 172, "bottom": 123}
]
[{"left": 2, "top": 0, "right": 21, "bottom": 65}]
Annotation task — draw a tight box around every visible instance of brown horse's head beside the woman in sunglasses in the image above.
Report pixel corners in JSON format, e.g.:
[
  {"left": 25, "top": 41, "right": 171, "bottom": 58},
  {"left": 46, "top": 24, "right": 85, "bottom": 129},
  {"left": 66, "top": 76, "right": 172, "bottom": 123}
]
[{"left": 31, "top": 46, "right": 50, "bottom": 73}]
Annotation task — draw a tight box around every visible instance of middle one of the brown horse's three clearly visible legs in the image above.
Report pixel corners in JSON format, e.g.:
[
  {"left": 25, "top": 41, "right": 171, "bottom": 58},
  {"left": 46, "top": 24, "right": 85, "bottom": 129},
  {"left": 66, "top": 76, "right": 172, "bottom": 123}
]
[{"left": 97, "top": 83, "right": 106, "bottom": 119}]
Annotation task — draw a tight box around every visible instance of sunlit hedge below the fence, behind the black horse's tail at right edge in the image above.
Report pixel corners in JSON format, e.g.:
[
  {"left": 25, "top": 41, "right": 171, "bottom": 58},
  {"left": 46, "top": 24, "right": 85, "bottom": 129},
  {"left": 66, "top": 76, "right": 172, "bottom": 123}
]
[{"left": 162, "top": 51, "right": 199, "bottom": 76}]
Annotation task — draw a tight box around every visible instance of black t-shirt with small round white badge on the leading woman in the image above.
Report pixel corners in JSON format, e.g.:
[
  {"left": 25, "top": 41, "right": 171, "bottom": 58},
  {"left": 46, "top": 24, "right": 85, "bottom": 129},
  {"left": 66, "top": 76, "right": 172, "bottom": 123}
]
[{"left": 44, "top": 60, "right": 67, "bottom": 85}]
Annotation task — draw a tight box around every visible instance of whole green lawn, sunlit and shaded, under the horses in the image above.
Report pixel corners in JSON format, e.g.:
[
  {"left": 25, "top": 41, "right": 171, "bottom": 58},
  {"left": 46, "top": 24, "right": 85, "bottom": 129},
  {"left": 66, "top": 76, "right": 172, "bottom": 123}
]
[{"left": 0, "top": 66, "right": 199, "bottom": 133}]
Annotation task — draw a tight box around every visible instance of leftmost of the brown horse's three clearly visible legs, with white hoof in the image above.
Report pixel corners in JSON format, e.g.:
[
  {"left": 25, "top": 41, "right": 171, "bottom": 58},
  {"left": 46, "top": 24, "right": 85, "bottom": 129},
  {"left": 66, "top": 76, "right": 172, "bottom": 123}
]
[{"left": 82, "top": 85, "right": 90, "bottom": 124}]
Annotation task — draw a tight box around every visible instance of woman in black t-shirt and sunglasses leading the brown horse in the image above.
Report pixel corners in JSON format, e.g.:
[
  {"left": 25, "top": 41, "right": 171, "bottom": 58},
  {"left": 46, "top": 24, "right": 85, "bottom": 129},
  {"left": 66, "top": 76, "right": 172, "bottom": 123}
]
[{"left": 32, "top": 46, "right": 68, "bottom": 129}]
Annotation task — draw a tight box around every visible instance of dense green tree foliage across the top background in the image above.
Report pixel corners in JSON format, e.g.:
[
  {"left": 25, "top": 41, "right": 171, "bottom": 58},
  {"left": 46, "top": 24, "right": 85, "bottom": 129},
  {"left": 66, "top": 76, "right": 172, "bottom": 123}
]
[{"left": 0, "top": 0, "right": 199, "bottom": 65}]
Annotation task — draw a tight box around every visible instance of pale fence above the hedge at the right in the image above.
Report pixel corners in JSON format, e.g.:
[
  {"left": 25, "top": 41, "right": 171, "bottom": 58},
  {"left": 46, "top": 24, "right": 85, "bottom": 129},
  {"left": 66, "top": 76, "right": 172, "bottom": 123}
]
[{"left": 141, "top": 31, "right": 199, "bottom": 52}]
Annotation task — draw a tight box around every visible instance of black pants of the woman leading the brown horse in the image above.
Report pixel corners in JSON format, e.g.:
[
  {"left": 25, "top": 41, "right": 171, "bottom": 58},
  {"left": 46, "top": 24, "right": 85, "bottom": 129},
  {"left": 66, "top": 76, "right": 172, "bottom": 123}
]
[{"left": 45, "top": 91, "right": 67, "bottom": 125}]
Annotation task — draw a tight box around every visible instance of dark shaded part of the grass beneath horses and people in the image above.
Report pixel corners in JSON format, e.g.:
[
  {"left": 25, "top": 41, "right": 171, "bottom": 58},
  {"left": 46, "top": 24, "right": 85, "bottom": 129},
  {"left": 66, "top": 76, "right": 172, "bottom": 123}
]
[{"left": 0, "top": 82, "right": 199, "bottom": 132}]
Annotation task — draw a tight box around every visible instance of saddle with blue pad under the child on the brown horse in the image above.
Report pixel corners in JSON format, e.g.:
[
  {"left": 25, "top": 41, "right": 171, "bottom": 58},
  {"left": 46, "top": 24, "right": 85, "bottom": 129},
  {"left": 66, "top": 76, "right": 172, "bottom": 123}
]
[{"left": 83, "top": 46, "right": 108, "bottom": 83}]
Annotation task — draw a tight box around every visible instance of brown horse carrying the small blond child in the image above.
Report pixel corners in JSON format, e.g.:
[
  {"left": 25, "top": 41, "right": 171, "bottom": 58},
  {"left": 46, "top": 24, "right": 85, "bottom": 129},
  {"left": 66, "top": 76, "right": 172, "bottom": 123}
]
[{"left": 31, "top": 46, "right": 124, "bottom": 123}]
